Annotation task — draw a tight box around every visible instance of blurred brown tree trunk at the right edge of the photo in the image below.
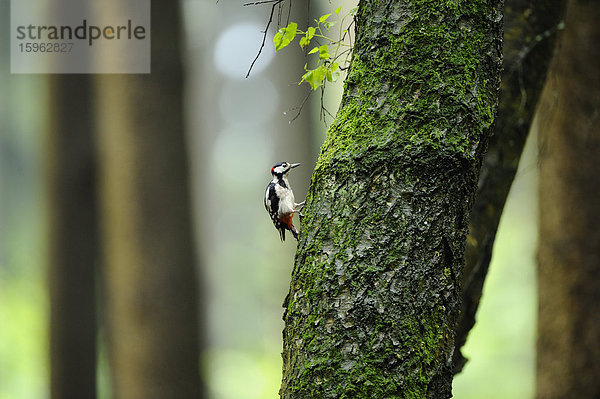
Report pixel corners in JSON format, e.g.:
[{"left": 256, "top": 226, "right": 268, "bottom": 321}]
[{"left": 537, "top": 0, "right": 600, "bottom": 399}]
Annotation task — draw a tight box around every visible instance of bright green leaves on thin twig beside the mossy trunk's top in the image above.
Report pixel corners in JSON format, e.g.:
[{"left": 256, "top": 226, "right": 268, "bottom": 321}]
[{"left": 273, "top": 7, "right": 358, "bottom": 90}]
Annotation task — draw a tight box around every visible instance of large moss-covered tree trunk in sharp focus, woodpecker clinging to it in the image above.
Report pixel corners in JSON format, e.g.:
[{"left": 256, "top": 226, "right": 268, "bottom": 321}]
[{"left": 280, "top": 1, "right": 502, "bottom": 398}]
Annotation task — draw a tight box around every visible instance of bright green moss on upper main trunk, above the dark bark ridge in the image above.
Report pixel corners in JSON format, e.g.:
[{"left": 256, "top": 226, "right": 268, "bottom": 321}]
[{"left": 318, "top": 1, "right": 497, "bottom": 178}]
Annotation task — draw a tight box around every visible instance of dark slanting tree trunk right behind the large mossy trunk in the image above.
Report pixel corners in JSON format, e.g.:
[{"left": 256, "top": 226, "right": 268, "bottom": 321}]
[{"left": 454, "top": 0, "right": 565, "bottom": 373}]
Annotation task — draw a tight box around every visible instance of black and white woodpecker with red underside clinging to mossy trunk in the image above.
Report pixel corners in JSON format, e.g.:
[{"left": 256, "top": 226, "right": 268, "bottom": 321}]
[{"left": 265, "top": 162, "right": 305, "bottom": 241}]
